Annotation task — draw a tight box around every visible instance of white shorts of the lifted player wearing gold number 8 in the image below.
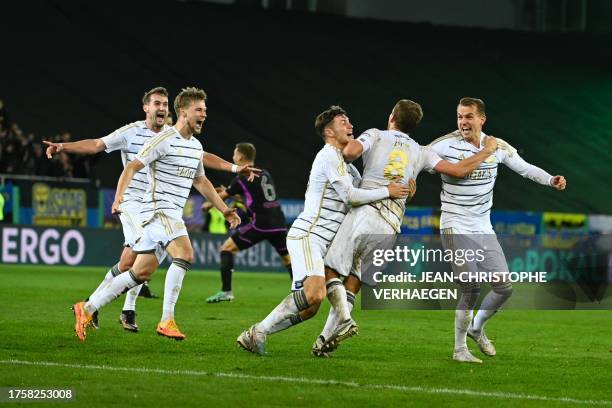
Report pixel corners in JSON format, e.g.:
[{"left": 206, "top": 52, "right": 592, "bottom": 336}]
[{"left": 325, "top": 205, "right": 397, "bottom": 280}]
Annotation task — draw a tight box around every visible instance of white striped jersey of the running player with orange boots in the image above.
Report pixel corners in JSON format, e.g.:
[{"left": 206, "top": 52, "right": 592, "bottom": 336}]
[{"left": 136, "top": 127, "right": 204, "bottom": 220}]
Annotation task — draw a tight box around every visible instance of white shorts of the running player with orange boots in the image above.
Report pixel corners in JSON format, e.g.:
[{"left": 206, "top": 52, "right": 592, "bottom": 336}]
[{"left": 132, "top": 213, "right": 182, "bottom": 263}]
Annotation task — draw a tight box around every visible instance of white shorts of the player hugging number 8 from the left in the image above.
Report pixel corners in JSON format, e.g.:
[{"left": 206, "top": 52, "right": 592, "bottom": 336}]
[{"left": 287, "top": 234, "right": 327, "bottom": 290}]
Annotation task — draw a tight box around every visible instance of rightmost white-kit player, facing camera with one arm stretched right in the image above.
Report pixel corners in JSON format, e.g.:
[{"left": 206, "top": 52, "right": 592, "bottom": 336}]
[{"left": 429, "top": 97, "right": 566, "bottom": 363}]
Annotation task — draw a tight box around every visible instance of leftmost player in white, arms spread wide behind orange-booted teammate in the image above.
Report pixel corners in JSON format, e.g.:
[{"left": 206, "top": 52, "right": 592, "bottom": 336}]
[{"left": 44, "top": 86, "right": 253, "bottom": 332}]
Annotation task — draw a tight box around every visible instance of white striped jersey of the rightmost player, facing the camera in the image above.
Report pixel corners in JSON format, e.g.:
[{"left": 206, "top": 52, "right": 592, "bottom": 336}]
[{"left": 430, "top": 130, "right": 552, "bottom": 233}]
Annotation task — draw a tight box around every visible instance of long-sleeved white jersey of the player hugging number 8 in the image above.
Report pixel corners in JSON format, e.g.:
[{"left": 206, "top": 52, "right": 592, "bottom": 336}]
[{"left": 288, "top": 144, "right": 389, "bottom": 245}]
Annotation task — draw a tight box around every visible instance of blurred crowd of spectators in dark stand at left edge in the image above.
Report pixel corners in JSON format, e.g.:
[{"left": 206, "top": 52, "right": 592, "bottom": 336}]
[{"left": 0, "top": 99, "right": 95, "bottom": 178}]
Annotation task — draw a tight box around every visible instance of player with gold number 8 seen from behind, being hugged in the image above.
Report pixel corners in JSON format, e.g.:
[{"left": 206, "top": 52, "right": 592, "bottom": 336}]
[{"left": 312, "top": 99, "right": 496, "bottom": 357}]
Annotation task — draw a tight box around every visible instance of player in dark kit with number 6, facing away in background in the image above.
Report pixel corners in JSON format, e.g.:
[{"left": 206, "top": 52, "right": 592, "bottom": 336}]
[{"left": 206, "top": 143, "right": 291, "bottom": 303}]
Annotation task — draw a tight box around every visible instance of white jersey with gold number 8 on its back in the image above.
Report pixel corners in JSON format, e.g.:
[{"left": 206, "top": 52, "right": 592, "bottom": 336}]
[{"left": 357, "top": 129, "right": 441, "bottom": 233}]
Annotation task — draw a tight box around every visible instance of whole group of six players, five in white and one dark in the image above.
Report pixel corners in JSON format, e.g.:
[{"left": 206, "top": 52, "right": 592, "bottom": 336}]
[{"left": 47, "top": 87, "right": 566, "bottom": 363}]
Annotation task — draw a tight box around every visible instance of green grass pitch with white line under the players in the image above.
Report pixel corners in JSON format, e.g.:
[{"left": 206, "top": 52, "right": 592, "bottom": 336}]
[{"left": 0, "top": 265, "right": 612, "bottom": 407}]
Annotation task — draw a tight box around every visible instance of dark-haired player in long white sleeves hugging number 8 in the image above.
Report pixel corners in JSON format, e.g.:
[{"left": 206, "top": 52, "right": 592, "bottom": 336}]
[{"left": 237, "top": 106, "right": 409, "bottom": 355}]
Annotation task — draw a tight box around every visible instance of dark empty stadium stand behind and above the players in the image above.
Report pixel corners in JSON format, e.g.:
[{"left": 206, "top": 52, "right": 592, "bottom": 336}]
[{"left": 0, "top": 1, "right": 612, "bottom": 214}]
